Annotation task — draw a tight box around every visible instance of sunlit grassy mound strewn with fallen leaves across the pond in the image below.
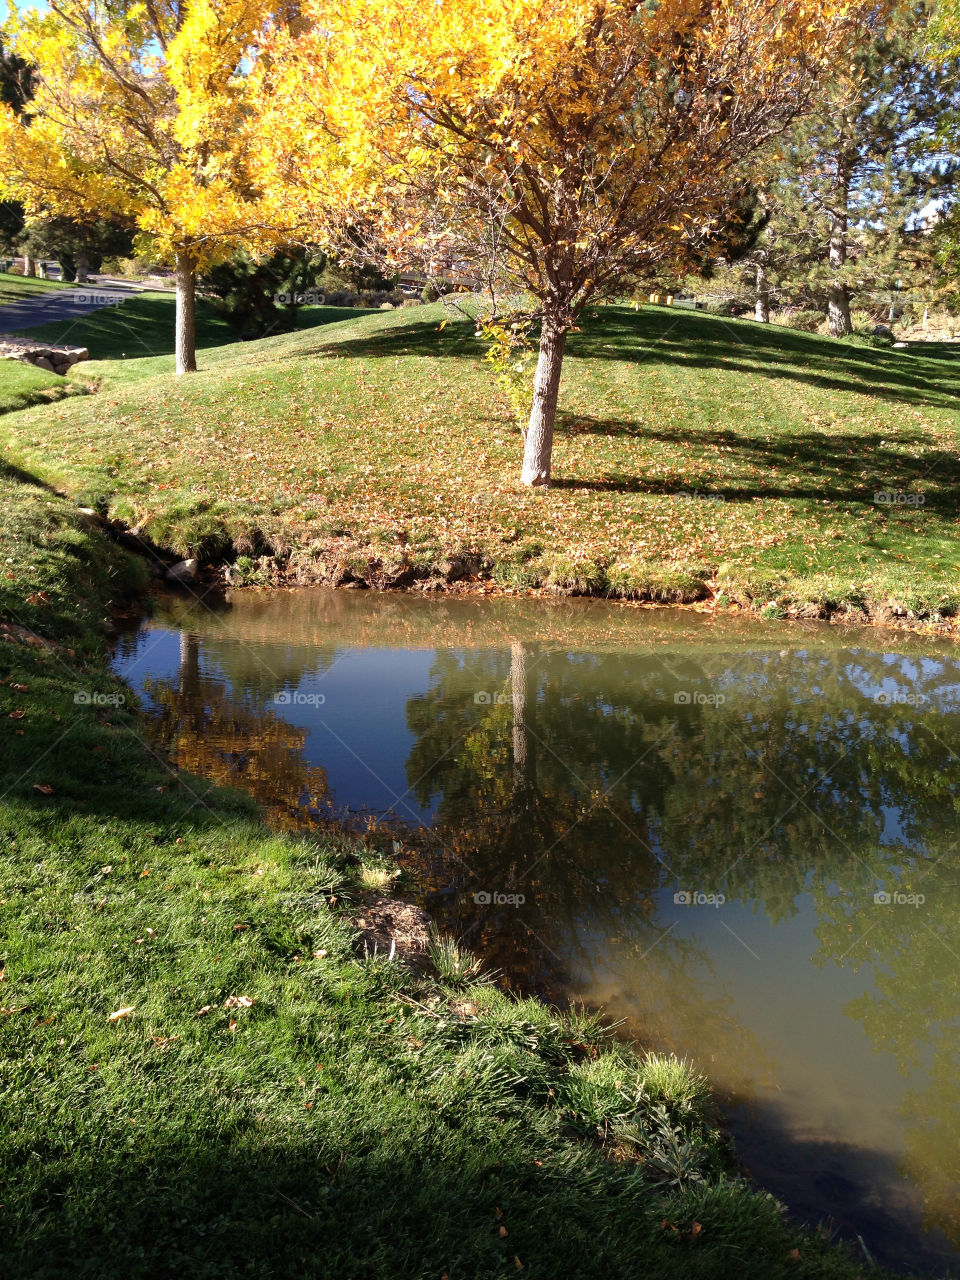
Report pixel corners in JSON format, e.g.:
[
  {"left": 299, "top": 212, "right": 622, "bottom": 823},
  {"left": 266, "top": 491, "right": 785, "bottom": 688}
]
[{"left": 0, "top": 305, "right": 960, "bottom": 620}]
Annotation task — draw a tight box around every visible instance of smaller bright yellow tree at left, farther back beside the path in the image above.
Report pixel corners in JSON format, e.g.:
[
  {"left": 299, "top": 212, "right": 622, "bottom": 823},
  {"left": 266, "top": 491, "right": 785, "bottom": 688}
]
[{"left": 0, "top": 0, "right": 276, "bottom": 372}]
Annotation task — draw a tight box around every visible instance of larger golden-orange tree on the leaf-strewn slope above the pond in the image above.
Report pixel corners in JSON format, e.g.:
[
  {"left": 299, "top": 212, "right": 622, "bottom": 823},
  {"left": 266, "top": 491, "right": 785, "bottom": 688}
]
[{"left": 260, "top": 0, "right": 883, "bottom": 485}]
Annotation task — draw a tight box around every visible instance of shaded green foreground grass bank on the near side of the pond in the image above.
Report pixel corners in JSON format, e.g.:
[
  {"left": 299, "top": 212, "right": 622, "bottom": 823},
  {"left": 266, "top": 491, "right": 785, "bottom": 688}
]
[{"left": 0, "top": 455, "right": 896, "bottom": 1280}]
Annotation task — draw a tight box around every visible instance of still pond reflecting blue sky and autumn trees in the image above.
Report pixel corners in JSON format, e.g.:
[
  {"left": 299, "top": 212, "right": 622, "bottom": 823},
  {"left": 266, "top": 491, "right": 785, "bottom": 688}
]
[{"left": 115, "top": 591, "right": 960, "bottom": 1275}]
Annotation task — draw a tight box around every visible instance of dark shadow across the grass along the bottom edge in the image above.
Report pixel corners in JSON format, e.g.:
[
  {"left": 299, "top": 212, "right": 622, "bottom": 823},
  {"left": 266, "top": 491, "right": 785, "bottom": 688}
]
[{"left": 4, "top": 1100, "right": 947, "bottom": 1280}]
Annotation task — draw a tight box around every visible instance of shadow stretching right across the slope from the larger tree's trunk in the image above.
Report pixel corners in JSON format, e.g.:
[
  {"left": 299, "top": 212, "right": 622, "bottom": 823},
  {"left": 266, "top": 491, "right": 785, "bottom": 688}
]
[{"left": 553, "top": 415, "right": 960, "bottom": 518}]
